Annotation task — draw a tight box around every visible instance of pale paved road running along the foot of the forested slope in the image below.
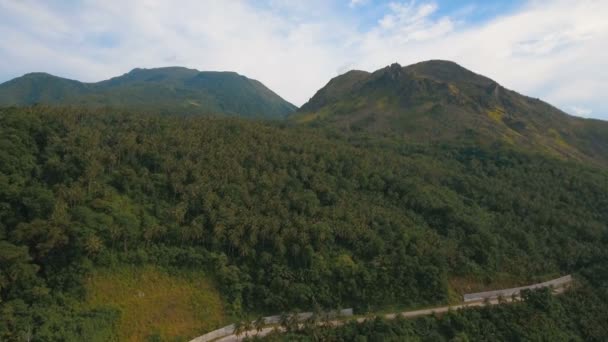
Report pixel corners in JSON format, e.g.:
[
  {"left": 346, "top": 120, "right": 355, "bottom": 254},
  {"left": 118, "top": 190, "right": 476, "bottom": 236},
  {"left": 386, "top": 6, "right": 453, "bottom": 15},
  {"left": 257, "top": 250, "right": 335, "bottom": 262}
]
[{"left": 215, "top": 287, "right": 565, "bottom": 342}]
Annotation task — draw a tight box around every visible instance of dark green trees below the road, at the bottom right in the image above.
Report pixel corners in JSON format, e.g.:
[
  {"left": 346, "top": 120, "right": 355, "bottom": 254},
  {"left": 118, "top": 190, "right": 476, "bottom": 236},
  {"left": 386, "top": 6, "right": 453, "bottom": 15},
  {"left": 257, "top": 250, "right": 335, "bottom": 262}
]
[{"left": 251, "top": 288, "right": 608, "bottom": 342}]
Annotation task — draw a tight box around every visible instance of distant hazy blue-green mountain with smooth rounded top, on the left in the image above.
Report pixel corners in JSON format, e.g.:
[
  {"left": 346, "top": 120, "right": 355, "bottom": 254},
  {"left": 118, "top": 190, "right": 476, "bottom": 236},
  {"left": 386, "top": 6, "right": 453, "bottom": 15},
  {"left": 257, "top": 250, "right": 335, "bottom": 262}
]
[{"left": 0, "top": 67, "right": 296, "bottom": 118}]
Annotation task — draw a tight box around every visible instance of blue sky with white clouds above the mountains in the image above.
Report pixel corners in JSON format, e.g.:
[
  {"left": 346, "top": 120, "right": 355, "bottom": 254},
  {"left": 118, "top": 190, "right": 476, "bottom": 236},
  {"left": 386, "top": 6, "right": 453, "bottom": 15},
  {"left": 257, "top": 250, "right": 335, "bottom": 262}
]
[{"left": 0, "top": 0, "right": 608, "bottom": 120}]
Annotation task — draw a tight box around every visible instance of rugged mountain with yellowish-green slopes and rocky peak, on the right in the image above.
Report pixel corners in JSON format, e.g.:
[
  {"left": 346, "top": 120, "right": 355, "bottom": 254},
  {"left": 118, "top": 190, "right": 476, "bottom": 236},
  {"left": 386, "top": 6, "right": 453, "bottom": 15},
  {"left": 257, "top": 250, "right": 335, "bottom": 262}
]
[{"left": 292, "top": 60, "right": 608, "bottom": 165}]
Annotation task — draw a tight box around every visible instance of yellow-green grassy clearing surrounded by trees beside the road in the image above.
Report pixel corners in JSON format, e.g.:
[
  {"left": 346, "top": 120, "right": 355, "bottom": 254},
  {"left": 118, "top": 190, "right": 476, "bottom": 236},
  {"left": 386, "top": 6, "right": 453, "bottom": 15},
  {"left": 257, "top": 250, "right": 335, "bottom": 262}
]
[{"left": 86, "top": 266, "right": 226, "bottom": 341}]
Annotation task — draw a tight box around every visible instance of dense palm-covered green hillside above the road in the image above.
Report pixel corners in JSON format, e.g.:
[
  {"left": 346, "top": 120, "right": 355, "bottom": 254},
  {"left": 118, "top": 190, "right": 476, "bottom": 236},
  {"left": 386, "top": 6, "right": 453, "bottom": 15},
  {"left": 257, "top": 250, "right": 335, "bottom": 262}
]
[{"left": 0, "top": 106, "right": 608, "bottom": 341}]
